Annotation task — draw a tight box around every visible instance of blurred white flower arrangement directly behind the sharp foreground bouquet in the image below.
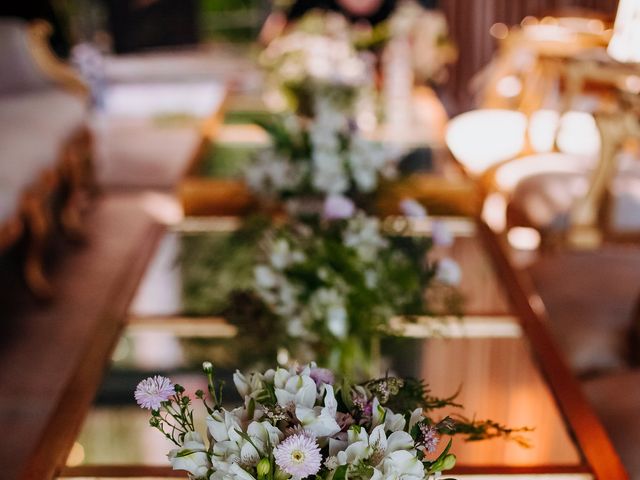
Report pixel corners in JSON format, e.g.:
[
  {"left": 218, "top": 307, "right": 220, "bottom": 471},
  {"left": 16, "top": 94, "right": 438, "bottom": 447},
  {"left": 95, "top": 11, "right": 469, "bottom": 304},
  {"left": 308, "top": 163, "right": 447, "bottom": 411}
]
[{"left": 240, "top": 204, "right": 461, "bottom": 378}]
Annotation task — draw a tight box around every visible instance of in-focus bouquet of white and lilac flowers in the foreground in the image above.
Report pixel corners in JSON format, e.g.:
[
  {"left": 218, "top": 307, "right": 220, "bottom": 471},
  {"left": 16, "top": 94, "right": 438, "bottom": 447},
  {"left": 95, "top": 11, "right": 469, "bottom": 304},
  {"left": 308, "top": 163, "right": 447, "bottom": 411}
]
[{"left": 135, "top": 362, "right": 528, "bottom": 480}]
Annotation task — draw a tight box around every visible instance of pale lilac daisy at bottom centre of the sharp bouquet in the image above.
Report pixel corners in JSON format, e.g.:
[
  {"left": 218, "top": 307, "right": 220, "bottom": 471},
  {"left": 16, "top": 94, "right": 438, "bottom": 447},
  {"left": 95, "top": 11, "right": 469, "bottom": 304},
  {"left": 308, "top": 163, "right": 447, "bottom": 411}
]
[{"left": 273, "top": 433, "right": 322, "bottom": 480}]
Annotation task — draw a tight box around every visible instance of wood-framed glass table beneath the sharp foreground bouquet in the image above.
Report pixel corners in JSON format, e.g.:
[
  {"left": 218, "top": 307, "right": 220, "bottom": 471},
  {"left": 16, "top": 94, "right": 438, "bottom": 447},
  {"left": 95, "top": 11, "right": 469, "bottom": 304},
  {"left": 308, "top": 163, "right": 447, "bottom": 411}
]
[{"left": 51, "top": 218, "right": 627, "bottom": 480}]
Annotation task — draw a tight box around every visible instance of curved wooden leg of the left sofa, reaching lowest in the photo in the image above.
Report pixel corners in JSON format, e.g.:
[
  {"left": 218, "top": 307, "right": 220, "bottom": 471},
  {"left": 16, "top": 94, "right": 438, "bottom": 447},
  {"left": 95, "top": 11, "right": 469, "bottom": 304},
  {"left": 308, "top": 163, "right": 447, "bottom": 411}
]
[{"left": 24, "top": 189, "right": 53, "bottom": 299}]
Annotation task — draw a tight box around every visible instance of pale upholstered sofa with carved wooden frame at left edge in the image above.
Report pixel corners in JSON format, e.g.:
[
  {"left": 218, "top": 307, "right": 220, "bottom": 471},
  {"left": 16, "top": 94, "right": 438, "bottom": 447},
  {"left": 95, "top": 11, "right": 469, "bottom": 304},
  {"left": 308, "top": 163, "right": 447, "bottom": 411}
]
[{"left": 0, "top": 18, "right": 88, "bottom": 296}]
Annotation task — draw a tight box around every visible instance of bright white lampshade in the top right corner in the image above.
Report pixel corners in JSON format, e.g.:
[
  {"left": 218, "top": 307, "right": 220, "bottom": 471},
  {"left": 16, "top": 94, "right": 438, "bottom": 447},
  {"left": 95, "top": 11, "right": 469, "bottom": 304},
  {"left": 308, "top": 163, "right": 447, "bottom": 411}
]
[{"left": 607, "top": 0, "right": 640, "bottom": 63}]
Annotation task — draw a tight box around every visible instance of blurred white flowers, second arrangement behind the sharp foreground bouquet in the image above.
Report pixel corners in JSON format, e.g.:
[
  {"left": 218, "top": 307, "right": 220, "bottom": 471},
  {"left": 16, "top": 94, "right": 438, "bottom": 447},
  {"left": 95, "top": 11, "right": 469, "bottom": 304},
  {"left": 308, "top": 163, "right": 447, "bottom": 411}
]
[{"left": 246, "top": 111, "right": 396, "bottom": 213}]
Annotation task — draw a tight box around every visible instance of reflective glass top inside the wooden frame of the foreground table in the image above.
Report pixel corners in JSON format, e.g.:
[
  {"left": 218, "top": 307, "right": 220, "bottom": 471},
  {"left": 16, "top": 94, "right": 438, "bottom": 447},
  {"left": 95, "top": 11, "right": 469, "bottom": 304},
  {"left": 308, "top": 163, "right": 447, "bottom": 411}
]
[{"left": 62, "top": 218, "right": 593, "bottom": 479}]
